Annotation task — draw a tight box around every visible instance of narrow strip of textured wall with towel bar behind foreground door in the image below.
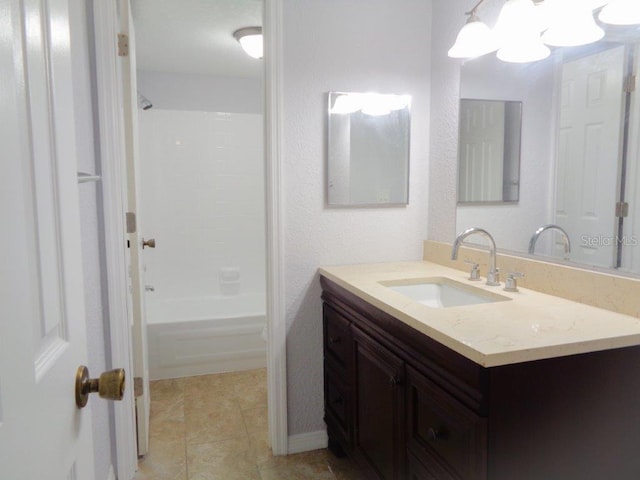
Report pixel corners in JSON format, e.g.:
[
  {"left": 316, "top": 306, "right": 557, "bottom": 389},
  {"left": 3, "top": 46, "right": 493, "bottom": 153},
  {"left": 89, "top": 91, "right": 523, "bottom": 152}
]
[{"left": 69, "top": 0, "right": 113, "bottom": 480}]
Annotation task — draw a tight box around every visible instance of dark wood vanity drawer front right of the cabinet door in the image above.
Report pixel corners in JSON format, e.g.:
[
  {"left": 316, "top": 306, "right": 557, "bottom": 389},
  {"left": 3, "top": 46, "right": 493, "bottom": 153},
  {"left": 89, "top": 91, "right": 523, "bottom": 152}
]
[{"left": 407, "top": 366, "right": 487, "bottom": 480}]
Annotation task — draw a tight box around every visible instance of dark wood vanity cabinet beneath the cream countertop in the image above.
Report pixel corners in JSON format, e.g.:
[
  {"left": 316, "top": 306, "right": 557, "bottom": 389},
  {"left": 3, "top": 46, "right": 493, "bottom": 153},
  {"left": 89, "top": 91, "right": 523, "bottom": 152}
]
[{"left": 321, "top": 277, "right": 640, "bottom": 480}]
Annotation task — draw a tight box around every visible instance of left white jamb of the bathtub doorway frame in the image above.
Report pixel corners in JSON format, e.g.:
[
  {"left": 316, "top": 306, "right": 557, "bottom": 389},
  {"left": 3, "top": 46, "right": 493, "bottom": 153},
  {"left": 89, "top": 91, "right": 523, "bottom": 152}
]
[{"left": 92, "top": 0, "right": 138, "bottom": 480}]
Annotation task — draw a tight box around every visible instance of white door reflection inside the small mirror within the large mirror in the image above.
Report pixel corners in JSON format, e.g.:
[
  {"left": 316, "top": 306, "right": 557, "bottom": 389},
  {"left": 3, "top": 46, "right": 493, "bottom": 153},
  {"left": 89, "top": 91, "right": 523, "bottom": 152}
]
[{"left": 458, "top": 100, "right": 505, "bottom": 202}]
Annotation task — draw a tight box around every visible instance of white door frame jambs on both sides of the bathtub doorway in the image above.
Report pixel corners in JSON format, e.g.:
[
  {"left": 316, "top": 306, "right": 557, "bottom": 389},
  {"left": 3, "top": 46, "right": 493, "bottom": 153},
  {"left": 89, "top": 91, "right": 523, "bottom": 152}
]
[{"left": 93, "top": 0, "right": 288, "bottom": 474}]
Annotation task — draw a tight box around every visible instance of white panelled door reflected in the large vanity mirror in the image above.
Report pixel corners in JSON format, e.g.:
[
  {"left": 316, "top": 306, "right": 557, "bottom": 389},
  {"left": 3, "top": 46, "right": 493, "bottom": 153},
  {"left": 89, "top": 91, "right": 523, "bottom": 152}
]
[{"left": 556, "top": 46, "right": 625, "bottom": 267}]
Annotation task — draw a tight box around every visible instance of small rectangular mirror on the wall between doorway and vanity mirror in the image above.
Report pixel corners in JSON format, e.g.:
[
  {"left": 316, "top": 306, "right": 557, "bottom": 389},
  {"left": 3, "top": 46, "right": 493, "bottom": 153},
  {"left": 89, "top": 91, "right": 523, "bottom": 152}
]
[{"left": 327, "top": 92, "right": 411, "bottom": 206}]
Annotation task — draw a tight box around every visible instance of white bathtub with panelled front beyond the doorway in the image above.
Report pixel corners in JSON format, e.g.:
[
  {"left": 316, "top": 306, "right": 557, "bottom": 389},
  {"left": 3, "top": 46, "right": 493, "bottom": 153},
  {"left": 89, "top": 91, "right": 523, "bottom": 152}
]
[{"left": 147, "top": 294, "right": 267, "bottom": 380}]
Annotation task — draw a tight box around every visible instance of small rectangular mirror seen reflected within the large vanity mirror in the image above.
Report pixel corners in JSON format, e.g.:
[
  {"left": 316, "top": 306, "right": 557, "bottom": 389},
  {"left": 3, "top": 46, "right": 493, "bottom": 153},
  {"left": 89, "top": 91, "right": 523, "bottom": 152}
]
[{"left": 458, "top": 98, "right": 522, "bottom": 204}]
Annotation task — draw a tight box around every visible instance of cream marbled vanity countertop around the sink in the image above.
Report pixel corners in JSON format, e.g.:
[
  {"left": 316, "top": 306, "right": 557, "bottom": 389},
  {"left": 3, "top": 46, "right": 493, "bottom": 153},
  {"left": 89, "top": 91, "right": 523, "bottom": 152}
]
[{"left": 320, "top": 262, "right": 640, "bottom": 367}]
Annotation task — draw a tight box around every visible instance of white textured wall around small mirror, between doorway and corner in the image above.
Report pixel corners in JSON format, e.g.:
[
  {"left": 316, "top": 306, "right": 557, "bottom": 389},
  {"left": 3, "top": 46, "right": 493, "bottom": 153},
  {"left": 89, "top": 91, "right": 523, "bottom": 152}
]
[{"left": 282, "top": 0, "right": 431, "bottom": 435}]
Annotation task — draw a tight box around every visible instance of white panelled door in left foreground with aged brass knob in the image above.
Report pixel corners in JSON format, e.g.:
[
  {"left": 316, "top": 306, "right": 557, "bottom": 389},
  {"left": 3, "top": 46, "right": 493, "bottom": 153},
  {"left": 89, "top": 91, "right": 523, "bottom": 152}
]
[{"left": 0, "top": 0, "right": 99, "bottom": 480}]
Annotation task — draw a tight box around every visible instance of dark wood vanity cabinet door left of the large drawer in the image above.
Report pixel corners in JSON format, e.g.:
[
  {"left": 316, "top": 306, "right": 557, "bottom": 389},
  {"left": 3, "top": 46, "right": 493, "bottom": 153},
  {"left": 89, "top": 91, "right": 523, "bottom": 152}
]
[{"left": 353, "top": 327, "right": 404, "bottom": 480}]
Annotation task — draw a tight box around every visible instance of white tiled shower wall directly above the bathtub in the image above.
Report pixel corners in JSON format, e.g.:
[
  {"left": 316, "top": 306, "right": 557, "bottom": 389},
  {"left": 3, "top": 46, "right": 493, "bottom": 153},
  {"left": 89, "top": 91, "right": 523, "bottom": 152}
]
[{"left": 138, "top": 107, "right": 266, "bottom": 308}]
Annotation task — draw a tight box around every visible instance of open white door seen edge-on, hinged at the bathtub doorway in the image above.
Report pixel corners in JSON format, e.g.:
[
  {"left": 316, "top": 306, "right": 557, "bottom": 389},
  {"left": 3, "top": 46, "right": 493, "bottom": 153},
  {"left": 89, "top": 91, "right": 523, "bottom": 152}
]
[{"left": 120, "top": 0, "right": 150, "bottom": 455}]
